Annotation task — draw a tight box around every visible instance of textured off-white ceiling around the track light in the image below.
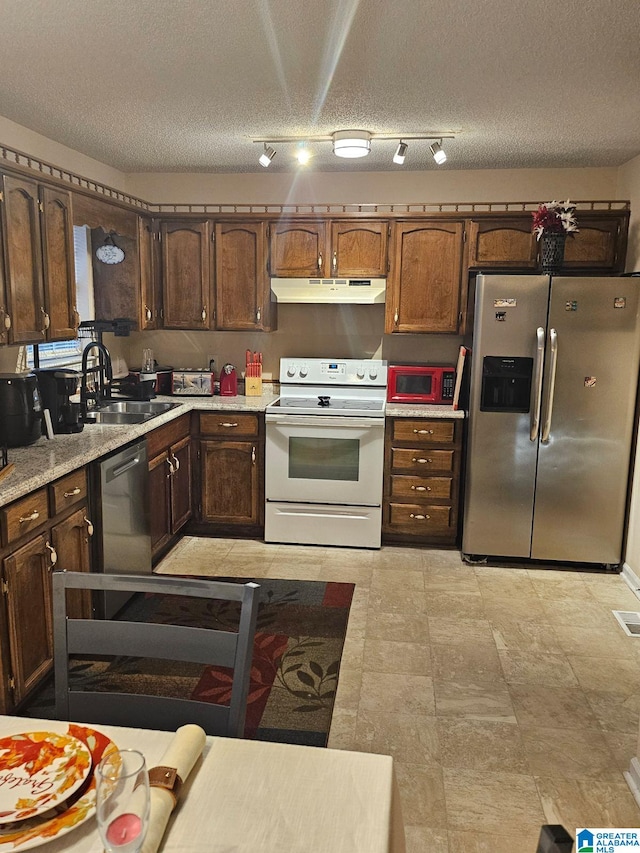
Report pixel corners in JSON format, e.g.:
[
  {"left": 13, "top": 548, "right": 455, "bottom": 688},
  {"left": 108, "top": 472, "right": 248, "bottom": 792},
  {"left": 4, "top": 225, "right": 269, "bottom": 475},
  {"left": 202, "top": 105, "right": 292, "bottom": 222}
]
[{"left": 0, "top": 0, "right": 640, "bottom": 172}]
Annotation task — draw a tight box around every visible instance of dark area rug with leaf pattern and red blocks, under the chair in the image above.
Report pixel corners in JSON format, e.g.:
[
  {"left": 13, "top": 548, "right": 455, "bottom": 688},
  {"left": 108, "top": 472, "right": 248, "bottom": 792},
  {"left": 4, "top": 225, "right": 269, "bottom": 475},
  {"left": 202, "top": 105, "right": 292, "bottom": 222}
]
[{"left": 19, "top": 578, "right": 354, "bottom": 746}]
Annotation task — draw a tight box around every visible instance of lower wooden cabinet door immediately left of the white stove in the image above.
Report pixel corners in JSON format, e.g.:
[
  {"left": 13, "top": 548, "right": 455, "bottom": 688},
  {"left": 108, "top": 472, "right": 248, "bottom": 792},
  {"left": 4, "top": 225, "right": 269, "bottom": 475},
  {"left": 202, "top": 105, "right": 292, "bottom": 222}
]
[{"left": 200, "top": 441, "right": 258, "bottom": 524}]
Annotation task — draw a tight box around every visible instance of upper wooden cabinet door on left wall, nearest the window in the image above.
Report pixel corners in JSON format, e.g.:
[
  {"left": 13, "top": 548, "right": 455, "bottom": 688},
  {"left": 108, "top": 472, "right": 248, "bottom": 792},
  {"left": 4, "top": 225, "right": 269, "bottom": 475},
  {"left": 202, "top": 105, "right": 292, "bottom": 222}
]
[{"left": 41, "top": 187, "right": 80, "bottom": 341}]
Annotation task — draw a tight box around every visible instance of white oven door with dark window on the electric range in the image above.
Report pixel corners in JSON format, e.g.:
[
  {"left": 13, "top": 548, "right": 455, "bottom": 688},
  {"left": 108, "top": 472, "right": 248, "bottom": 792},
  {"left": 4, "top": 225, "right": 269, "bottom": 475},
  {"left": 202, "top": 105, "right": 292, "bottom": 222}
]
[{"left": 265, "top": 414, "right": 384, "bottom": 506}]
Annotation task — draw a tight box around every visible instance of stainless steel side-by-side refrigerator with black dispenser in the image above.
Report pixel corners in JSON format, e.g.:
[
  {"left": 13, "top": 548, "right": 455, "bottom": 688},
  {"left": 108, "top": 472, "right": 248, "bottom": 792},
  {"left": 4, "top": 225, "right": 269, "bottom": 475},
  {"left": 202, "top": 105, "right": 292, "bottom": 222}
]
[{"left": 462, "top": 275, "right": 640, "bottom": 567}]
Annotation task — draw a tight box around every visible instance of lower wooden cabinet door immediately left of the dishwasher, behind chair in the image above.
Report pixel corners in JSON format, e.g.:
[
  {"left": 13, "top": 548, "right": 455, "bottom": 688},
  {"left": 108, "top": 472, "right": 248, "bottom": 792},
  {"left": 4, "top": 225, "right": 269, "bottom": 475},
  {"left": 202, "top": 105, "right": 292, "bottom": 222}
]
[{"left": 51, "top": 507, "right": 93, "bottom": 619}]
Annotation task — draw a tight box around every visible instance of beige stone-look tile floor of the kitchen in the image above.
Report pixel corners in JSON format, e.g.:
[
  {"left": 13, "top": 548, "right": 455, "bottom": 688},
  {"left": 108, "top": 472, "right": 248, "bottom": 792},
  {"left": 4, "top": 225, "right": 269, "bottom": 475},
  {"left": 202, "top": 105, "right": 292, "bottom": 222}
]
[{"left": 158, "top": 537, "right": 640, "bottom": 853}]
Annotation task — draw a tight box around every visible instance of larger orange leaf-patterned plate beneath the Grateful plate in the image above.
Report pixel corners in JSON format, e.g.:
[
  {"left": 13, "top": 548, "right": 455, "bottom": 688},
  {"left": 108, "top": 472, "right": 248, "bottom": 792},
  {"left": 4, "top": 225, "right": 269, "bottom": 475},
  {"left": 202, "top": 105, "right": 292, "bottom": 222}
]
[{"left": 0, "top": 723, "right": 117, "bottom": 853}]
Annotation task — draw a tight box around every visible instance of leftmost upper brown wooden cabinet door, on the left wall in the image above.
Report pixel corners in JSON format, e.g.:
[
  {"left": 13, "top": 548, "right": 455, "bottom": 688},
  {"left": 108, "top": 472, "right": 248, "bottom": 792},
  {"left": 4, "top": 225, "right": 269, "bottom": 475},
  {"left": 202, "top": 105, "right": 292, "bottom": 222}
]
[{"left": 3, "top": 175, "right": 49, "bottom": 344}]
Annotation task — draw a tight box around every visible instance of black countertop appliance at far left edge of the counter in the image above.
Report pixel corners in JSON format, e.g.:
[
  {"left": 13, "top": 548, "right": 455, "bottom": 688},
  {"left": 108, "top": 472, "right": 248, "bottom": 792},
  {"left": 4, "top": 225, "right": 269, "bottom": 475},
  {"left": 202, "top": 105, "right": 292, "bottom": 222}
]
[{"left": 0, "top": 372, "right": 42, "bottom": 447}]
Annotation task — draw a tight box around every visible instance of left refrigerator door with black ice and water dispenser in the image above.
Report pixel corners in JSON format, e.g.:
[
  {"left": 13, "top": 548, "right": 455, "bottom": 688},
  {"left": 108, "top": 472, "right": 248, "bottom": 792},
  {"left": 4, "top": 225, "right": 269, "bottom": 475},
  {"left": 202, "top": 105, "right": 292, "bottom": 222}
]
[{"left": 462, "top": 276, "right": 549, "bottom": 557}]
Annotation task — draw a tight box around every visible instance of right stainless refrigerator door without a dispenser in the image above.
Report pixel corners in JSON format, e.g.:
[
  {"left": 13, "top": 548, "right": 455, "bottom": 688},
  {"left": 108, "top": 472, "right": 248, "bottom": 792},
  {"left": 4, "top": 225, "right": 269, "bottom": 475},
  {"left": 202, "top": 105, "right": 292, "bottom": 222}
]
[{"left": 531, "top": 278, "right": 640, "bottom": 564}]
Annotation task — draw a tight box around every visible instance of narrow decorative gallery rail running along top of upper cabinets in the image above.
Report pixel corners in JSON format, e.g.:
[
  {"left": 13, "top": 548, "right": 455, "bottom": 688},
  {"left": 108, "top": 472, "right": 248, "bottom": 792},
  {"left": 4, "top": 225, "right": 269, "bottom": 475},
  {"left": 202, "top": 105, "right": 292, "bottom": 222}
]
[{"left": 0, "top": 145, "right": 631, "bottom": 216}]
